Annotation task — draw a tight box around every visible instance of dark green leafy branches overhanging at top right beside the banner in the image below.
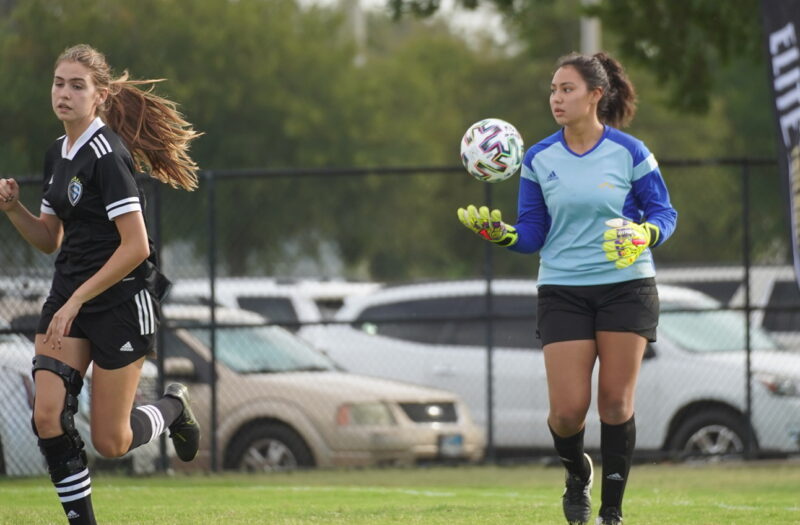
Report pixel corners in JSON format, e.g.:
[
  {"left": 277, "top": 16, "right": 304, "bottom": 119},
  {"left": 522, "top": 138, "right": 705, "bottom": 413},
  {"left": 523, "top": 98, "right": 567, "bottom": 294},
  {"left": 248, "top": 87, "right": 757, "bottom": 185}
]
[{"left": 387, "top": 0, "right": 763, "bottom": 111}]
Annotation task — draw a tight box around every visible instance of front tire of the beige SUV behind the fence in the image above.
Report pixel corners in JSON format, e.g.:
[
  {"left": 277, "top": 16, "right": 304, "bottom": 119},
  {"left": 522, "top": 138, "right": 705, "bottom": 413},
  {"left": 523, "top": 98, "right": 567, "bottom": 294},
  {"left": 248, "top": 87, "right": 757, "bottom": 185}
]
[{"left": 225, "top": 423, "right": 314, "bottom": 472}]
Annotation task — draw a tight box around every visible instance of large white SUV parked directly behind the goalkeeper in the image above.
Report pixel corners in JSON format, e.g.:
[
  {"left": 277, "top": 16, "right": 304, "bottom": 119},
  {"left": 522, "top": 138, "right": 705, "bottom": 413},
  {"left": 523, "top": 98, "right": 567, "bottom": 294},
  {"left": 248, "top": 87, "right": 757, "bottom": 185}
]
[{"left": 308, "top": 280, "right": 800, "bottom": 455}]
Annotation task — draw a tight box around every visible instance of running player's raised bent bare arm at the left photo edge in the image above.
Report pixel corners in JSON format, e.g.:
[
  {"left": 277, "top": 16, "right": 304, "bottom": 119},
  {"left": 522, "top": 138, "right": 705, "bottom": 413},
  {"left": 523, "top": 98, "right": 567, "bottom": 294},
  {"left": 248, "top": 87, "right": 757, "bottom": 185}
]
[{"left": 0, "top": 179, "right": 64, "bottom": 253}]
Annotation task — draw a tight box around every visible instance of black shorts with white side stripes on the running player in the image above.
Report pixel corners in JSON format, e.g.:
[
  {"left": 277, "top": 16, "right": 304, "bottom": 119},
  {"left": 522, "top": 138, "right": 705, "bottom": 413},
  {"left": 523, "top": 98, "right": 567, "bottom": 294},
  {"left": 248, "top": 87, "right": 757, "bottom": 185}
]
[{"left": 36, "top": 290, "right": 161, "bottom": 370}]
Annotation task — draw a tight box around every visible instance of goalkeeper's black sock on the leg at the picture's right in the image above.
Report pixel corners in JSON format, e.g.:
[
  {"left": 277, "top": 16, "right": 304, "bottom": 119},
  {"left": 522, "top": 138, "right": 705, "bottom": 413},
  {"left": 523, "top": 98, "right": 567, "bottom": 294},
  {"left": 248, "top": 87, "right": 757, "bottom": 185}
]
[{"left": 600, "top": 416, "right": 636, "bottom": 511}]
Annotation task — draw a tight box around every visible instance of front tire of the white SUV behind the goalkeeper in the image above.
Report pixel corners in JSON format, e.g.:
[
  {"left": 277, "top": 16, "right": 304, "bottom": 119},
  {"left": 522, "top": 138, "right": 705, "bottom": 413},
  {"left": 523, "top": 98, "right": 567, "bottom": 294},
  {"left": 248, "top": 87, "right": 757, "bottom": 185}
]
[{"left": 668, "top": 410, "right": 747, "bottom": 460}]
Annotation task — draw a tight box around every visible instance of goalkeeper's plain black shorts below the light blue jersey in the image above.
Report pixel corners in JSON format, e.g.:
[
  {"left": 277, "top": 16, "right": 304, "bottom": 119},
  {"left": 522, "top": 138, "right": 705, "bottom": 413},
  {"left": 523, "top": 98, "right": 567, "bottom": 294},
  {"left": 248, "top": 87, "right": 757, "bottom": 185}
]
[{"left": 537, "top": 277, "right": 659, "bottom": 345}]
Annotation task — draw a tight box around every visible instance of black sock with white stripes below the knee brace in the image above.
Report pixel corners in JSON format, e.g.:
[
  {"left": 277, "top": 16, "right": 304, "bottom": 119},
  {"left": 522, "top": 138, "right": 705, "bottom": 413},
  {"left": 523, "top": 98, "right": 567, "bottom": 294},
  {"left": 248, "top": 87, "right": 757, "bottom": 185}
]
[{"left": 39, "top": 434, "right": 97, "bottom": 525}]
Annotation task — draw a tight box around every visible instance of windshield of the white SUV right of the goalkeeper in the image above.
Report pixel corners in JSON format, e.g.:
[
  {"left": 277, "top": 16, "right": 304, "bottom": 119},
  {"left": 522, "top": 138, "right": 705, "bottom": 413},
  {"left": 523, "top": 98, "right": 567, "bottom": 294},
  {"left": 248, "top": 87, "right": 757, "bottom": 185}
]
[{"left": 658, "top": 309, "right": 778, "bottom": 352}]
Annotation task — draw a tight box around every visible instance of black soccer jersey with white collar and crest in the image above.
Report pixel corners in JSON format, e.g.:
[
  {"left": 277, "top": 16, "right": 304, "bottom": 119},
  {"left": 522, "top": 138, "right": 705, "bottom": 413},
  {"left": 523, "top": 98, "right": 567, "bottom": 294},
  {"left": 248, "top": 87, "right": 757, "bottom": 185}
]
[{"left": 41, "top": 118, "right": 157, "bottom": 312}]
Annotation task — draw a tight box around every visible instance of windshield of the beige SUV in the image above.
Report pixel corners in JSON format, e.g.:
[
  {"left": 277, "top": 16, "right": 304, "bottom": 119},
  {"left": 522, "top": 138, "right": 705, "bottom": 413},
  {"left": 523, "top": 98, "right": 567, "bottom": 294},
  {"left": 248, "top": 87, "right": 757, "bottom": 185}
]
[{"left": 189, "top": 326, "right": 336, "bottom": 374}]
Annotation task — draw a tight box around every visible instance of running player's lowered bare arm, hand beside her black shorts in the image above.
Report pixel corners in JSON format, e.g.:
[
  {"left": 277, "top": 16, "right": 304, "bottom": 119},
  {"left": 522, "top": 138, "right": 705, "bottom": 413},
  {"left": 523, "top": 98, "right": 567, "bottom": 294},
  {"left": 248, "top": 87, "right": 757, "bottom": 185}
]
[{"left": 45, "top": 211, "right": 150, "bottom": 341}]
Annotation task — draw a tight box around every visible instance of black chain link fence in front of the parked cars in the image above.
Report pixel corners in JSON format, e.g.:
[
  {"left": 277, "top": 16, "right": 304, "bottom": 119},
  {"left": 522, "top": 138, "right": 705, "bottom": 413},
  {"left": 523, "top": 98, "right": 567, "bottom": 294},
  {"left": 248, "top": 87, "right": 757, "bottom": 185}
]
[{"left": 0, "top": 159, "right": 800, "bottom": 475}]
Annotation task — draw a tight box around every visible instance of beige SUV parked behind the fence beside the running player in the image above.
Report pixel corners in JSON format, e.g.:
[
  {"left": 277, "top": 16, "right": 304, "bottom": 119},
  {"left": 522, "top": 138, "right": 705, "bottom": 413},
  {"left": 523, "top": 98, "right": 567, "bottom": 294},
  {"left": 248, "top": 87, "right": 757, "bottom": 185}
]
[{"left": 156, "top": 304, "right": 485, "bottom": 471}]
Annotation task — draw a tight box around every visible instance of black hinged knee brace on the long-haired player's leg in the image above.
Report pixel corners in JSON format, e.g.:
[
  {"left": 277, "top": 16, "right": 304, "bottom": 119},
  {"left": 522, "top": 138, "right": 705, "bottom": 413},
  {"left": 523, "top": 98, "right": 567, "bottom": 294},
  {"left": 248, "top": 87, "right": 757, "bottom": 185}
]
[{"left": 31, "top": 355, "right": 88, "bottom": 481}]
